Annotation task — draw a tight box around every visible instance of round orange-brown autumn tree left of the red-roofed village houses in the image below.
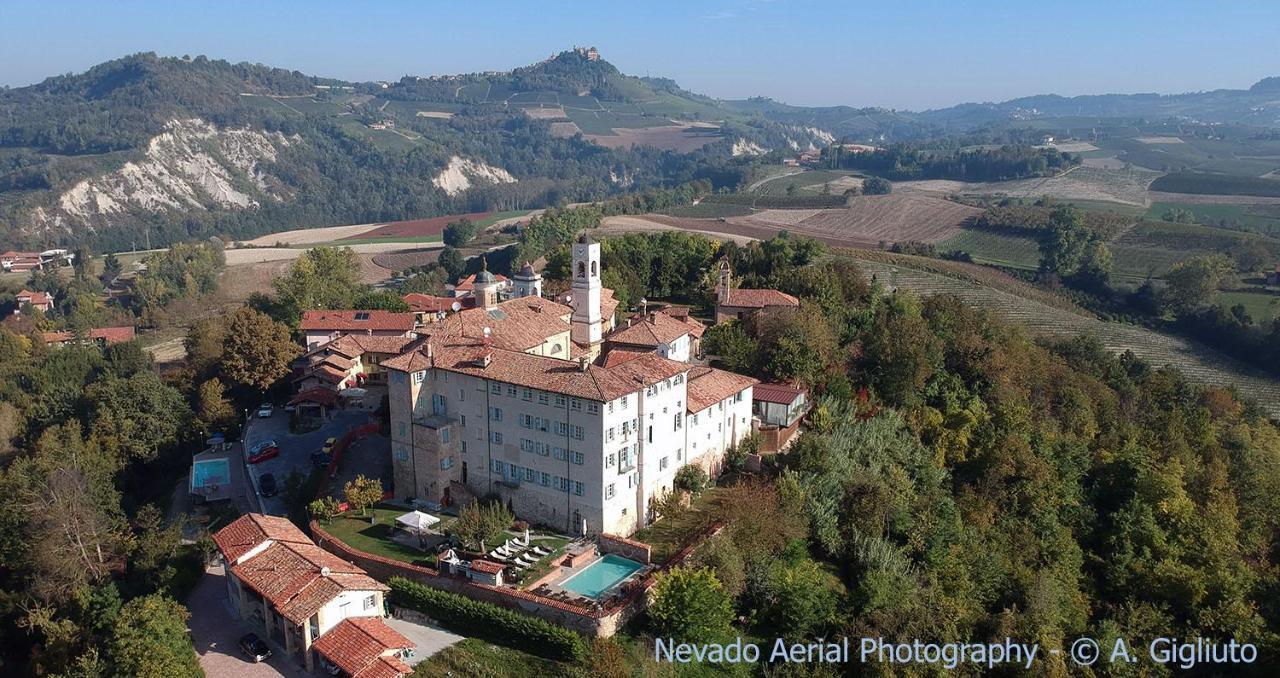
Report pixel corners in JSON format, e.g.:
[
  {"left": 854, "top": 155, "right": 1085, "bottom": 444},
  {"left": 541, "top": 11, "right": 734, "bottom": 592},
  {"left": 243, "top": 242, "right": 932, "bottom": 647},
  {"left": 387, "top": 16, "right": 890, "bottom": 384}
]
[{"left": 221, "top": 307, "right": 302, "bottom": 391}]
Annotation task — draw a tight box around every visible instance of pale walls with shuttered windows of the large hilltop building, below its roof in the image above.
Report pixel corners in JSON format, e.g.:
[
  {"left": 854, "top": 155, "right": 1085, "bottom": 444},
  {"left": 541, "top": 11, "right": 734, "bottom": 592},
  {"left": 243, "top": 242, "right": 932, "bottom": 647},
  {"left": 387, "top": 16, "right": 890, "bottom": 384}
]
[{"left": 390, "top": 368, "right": 751, "bottom": 535}]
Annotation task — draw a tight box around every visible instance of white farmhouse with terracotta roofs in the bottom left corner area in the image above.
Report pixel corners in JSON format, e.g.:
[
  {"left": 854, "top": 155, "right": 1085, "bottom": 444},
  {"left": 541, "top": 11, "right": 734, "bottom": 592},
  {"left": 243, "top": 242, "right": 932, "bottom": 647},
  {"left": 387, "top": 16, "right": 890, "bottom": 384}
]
[{"left": 214, "top": 513, "right": 412, "bottom": 675}]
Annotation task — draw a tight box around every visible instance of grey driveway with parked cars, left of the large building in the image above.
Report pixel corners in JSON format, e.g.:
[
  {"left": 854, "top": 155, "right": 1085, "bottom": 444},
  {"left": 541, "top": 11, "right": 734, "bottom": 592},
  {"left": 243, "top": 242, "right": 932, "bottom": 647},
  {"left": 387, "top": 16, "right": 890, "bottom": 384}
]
[{"left": 243, "top": 409, "right": 373, "bottom": 516}]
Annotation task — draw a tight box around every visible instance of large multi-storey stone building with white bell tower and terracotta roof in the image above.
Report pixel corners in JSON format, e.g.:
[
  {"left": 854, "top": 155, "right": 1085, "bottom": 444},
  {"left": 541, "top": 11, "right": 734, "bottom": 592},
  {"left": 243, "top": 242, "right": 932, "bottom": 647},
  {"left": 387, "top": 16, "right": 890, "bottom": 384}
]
[{"left": 383, "top": 237, "right": 755, "bottom": 535}]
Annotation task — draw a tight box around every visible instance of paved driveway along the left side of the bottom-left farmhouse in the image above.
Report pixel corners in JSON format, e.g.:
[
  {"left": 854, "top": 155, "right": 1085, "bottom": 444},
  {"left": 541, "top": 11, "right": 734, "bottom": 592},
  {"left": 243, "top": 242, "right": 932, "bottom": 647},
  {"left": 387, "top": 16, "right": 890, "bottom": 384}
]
[{"left": 187, "top": 565, "right": 308, "bottom": 678}]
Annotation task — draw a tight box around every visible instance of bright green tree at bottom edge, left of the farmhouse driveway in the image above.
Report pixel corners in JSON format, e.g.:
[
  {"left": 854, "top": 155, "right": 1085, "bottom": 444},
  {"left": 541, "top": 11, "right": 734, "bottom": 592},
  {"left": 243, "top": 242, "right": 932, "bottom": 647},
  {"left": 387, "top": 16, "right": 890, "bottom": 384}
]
[{"left": 111, "top": 594, "right": 205, "bottom": 678}]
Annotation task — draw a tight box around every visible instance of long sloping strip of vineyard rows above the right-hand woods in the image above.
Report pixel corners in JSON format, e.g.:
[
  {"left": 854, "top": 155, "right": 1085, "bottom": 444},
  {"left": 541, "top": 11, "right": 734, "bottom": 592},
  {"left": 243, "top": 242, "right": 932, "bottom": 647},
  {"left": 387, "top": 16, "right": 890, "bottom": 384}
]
[{"left": 841, "top": 249, "right": 1280, "bottom": 417}]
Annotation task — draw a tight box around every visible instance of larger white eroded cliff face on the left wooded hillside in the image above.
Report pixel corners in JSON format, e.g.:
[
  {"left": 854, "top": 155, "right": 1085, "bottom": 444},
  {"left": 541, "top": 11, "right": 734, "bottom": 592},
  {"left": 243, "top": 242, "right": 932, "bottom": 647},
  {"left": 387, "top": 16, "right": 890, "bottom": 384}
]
[{"left": 31, "top": 118, "right": 302, "bottom": 236}]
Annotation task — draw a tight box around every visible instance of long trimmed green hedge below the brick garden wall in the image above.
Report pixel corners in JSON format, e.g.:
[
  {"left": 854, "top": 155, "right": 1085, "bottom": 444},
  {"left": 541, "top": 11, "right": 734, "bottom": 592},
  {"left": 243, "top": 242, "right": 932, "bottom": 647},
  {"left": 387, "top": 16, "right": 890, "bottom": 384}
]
[{"left": 387, "top": 577, "right": 586, "bottom": 661}]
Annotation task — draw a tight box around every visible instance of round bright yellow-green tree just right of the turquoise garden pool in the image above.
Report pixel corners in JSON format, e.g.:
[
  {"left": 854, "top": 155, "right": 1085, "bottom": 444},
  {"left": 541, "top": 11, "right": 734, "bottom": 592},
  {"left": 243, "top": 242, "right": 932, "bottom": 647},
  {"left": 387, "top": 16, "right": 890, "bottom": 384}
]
[{"left": 649, "top": 567, "right": 733, "bottom": 642}]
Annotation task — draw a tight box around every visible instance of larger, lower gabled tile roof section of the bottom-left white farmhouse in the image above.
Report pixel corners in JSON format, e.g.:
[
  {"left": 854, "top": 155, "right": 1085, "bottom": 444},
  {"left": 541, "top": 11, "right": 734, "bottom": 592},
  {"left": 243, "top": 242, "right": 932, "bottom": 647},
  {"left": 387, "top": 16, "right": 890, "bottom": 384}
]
[{"left": 230, "top": 541, "right": 388, "bottom": 624}]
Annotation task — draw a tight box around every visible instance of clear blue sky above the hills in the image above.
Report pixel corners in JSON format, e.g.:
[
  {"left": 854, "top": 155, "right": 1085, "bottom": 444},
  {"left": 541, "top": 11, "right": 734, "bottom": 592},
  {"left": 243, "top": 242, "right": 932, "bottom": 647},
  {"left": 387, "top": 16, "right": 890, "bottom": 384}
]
[{"left": 0, "top": 0, "right": 1280, "bottom": 110}]
